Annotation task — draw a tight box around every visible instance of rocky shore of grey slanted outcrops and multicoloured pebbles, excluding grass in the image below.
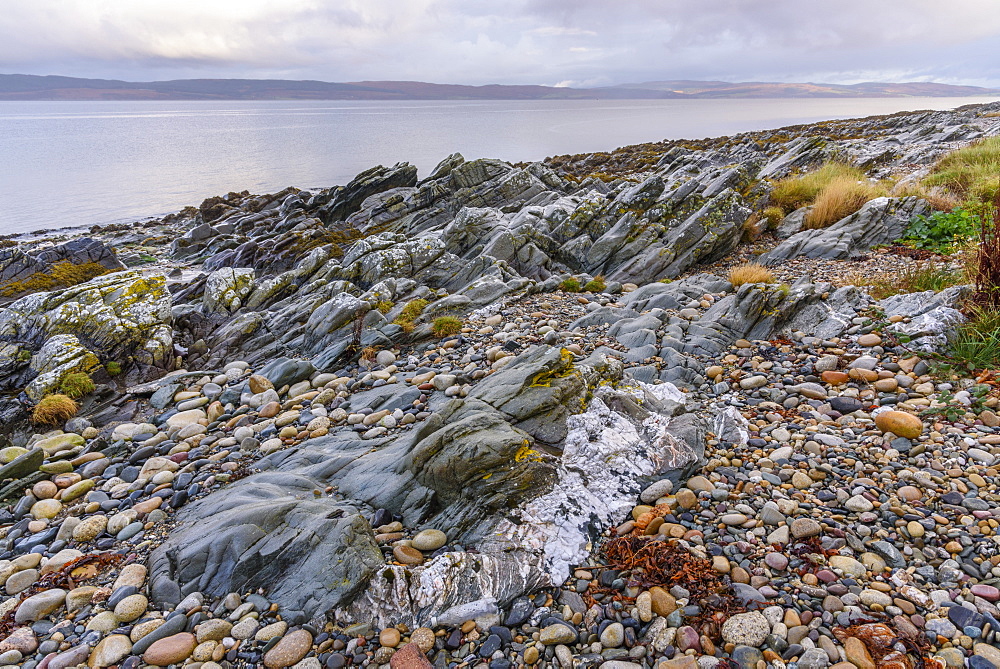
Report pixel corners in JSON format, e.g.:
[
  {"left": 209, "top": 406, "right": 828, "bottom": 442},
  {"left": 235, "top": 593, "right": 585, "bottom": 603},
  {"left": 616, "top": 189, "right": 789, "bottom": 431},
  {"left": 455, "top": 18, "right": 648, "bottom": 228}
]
[{"left": 0, "top": 104, "right": 1000, "bottom": 669}]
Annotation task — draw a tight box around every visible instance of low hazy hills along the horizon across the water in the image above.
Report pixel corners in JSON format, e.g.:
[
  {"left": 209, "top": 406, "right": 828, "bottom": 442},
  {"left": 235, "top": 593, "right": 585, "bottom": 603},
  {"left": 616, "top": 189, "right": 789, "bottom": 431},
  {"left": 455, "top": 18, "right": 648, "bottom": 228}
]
[{"left": 0, "top": 74, "right": 1000, "bottom": 100}]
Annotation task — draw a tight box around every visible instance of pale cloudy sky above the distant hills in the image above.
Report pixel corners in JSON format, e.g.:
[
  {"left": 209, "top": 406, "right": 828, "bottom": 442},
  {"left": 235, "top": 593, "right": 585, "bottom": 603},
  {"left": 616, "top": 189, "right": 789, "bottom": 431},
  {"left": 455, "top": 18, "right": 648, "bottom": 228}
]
[{"left": 0, "top": 0, "right": 1000, "bottom": 87}]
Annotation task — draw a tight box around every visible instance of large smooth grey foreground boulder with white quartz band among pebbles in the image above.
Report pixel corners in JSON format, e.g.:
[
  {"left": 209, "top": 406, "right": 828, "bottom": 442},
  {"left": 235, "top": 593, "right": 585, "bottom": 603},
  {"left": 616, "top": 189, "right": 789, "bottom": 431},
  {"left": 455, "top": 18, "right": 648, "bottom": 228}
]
[{"left": 151, "top": 346, "right": 704, "bottom": 626}]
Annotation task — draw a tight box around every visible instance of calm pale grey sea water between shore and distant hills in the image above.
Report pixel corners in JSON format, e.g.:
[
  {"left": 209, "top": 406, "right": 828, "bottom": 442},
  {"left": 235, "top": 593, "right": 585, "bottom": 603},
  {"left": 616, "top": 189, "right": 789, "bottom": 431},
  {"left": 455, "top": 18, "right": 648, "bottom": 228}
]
[{"left": 0, "top": 98, "right": 991, "bottom": 234}]
